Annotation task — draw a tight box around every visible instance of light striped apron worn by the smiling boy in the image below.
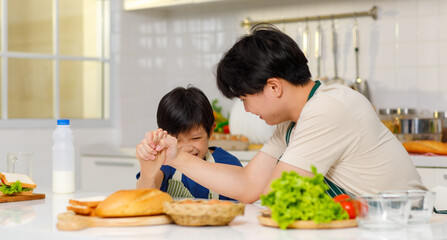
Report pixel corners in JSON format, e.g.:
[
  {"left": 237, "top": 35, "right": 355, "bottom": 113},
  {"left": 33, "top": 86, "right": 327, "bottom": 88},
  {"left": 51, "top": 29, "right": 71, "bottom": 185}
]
[{"left": 167, "top": 151, "right": 219, "bottom": 199}]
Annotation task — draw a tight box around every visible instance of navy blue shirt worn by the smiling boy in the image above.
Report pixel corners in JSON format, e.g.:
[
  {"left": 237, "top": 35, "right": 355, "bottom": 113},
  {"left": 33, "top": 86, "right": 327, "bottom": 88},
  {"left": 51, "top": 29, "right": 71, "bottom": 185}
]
[{"left": 137, "top": 147, "right": 242, "bottom": 200}]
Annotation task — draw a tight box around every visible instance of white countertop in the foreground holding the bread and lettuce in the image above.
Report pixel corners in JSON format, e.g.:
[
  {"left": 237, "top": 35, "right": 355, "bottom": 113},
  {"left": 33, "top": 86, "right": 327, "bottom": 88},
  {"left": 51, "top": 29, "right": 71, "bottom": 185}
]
[{"left": 0, "top": 189, "right": 447, "bottom": 240}]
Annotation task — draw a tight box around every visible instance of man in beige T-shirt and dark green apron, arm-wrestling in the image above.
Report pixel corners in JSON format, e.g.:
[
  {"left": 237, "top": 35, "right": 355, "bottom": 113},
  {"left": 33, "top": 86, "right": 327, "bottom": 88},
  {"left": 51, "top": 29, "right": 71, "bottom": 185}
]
[{"left": 137, "top": 25, "right": 426, "bottom": 203}]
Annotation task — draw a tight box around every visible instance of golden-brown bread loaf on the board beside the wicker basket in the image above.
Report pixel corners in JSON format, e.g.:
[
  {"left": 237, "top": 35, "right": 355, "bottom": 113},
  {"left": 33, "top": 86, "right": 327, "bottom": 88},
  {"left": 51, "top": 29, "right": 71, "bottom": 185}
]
[{"left": 94, "top": 188, "right": 172, "bottom": 217}]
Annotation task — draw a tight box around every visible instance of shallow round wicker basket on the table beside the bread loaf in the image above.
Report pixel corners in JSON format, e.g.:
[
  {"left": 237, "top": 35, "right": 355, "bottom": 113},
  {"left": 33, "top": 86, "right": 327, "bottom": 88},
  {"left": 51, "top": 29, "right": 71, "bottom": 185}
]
[{"left": 163, "top": 200, "right": 245, "bottom": 226}]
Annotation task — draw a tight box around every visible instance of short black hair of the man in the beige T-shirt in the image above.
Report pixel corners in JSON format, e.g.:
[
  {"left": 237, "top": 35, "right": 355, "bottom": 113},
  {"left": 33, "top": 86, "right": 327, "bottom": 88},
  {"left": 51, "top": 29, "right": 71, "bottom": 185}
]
[{"left": 216, "top": 23, "right": 311, "bottom": 98}]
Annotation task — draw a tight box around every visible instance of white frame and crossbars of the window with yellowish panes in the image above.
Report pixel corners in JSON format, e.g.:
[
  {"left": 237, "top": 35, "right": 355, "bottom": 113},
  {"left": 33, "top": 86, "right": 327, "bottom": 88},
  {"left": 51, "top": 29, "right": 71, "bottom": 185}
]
[{"left": 0, "top": 0, "right": 116, "bottom": 129}]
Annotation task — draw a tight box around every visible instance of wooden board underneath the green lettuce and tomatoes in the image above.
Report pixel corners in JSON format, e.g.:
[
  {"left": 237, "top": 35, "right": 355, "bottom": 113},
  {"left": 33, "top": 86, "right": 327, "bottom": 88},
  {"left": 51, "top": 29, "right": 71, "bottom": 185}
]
[{"left": 258, "top": 215, "right": 357, "bottom": 229}]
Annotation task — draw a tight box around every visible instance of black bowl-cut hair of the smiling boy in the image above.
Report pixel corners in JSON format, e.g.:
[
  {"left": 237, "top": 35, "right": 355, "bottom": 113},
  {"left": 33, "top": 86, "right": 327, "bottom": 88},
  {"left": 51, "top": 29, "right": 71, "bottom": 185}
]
[{"left": 157, "top": 86, "right": 214, "bottom": 137}]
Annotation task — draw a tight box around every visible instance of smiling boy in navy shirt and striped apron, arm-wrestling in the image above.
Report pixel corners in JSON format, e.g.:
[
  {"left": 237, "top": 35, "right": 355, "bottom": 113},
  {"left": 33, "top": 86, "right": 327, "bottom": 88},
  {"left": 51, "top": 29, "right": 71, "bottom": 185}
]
[{"left": 137, "top": 87, "right": 242, "bottom": 200}]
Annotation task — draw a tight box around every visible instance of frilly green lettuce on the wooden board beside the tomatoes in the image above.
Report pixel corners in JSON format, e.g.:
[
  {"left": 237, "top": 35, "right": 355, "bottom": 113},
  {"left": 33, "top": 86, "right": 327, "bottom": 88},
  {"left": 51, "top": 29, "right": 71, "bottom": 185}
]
[{"left": 261, "top": 166, "right": 349, "bottom": 229}]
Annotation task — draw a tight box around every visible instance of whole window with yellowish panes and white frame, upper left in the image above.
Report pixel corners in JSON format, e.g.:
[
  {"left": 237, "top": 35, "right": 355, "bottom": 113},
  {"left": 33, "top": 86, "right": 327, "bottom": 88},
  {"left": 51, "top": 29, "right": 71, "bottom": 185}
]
[{"left": 0, "top": 0, "right": 110, "bottom": 125}]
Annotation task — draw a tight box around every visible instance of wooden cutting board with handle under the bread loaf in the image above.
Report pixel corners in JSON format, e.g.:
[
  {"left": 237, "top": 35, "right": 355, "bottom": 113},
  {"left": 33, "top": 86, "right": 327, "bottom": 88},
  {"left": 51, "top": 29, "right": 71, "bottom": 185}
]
[{"left": 57, "top": 211, "right": 172, "bottom": 231}]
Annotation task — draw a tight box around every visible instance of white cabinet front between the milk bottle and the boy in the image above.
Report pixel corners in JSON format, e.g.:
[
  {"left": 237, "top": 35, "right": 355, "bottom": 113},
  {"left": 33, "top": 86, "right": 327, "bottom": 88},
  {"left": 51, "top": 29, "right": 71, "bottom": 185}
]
[{"left": 81, "top": 156, "right": 140, "bottom": 191}]
